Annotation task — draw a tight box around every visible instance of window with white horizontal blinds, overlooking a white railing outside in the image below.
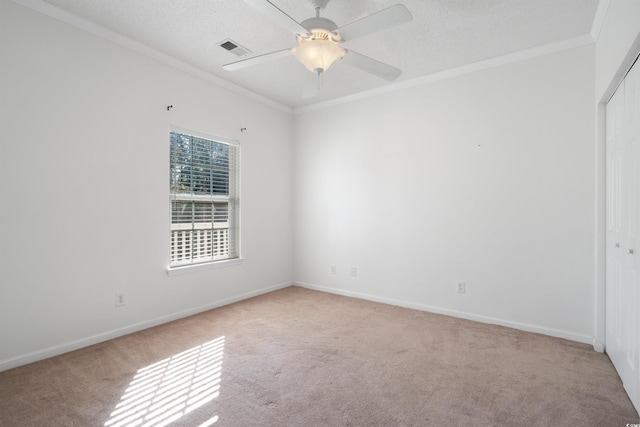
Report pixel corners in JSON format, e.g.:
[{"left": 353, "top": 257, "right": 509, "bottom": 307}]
[{"left": 169, "top": 130, "right": 240, "bottom": 267}]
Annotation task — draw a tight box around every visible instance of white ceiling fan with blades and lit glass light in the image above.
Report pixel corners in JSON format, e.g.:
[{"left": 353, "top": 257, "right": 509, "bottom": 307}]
[{"left": 222, "top": 0, "right": 413, "bottom": 85}]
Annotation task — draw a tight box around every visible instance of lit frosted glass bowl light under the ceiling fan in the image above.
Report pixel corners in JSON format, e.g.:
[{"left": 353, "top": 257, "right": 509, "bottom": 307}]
[{"left": 293, "top": 30, "right": 347, "bottom": 72}]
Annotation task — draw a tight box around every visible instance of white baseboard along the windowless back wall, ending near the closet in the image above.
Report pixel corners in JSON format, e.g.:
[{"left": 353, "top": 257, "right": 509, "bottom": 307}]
[{"left": 293, "top": 281, "right": 604, "bottom": 351}]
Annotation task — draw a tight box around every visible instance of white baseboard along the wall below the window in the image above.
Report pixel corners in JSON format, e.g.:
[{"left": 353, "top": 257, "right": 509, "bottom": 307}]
[{"left": 0, "top": 282, "right": 293, "bottom": 372}]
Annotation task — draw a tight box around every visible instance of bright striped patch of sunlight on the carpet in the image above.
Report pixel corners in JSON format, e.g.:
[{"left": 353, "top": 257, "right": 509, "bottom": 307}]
[{"left": 104, "top": 337, "right": 224, "bottom": 427}]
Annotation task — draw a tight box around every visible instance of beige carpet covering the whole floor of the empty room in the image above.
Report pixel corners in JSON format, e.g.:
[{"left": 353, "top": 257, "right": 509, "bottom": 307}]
[{"left": 0, "top": 287, "right": 639, "bottom": 427}]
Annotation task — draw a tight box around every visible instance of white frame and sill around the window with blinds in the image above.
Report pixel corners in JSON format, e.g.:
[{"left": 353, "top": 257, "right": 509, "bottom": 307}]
[{"left": 167, "top": 125, "right": 243, "bottom": 276}]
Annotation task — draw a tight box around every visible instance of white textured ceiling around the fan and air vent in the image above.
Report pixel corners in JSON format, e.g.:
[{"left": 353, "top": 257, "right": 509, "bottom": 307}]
[{"left": 36, "top": 0, "right": 598, "bottom": 108}]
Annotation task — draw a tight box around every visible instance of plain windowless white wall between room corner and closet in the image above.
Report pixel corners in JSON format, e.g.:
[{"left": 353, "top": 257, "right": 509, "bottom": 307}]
[{"left": 294, "top": 46, "right": 595, "bottom": 343}]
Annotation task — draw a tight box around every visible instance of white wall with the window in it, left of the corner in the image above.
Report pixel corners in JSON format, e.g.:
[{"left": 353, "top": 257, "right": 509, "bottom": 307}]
[{"left": 0, "top": 0, "right": 293, "bottom": 370}]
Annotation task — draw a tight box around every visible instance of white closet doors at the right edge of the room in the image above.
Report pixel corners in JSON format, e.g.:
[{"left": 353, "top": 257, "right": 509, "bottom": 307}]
[{"left": 606, "top": 58, "right": 640, "bottom": 409}]
